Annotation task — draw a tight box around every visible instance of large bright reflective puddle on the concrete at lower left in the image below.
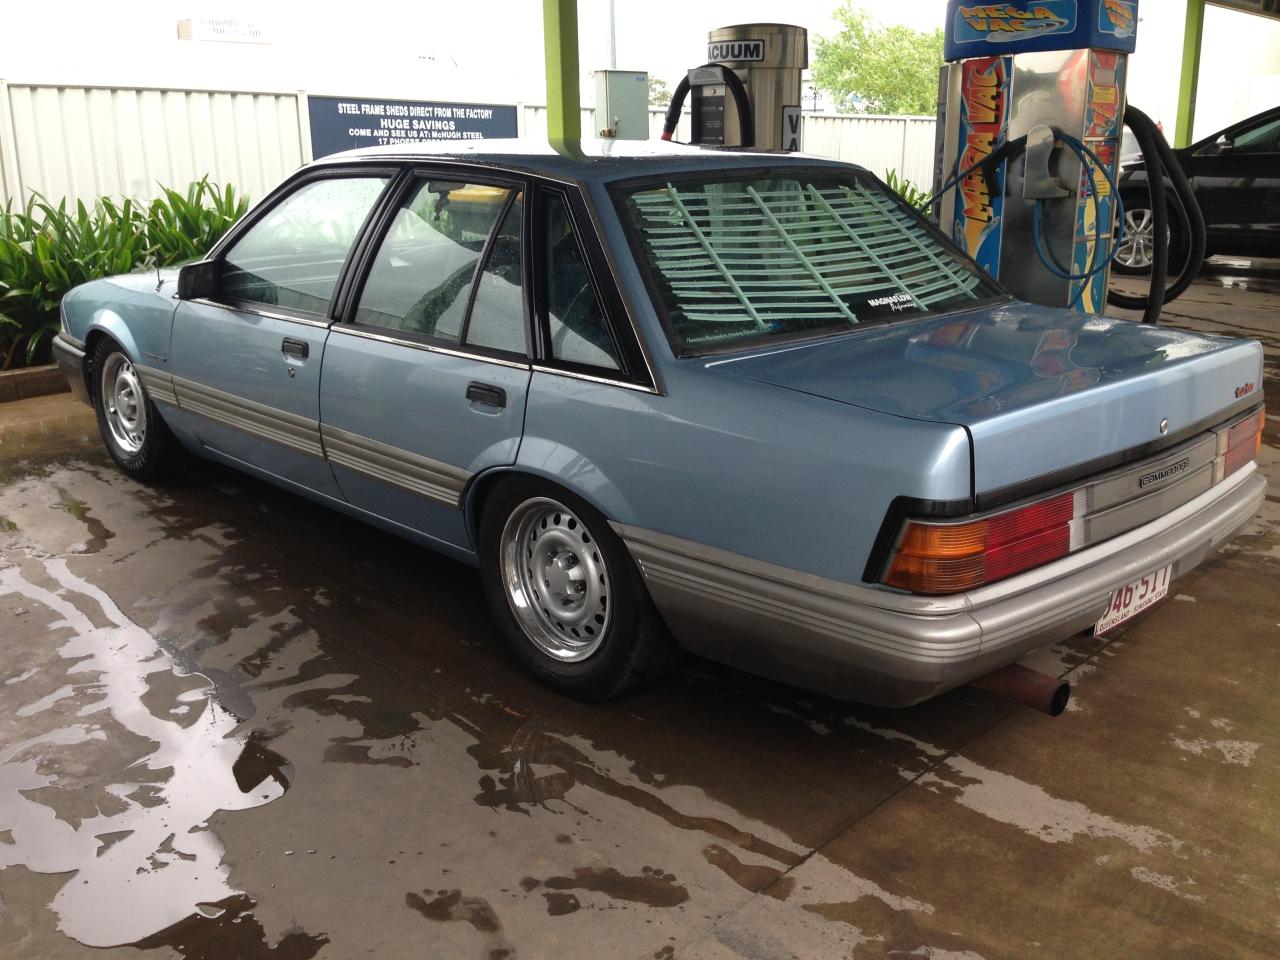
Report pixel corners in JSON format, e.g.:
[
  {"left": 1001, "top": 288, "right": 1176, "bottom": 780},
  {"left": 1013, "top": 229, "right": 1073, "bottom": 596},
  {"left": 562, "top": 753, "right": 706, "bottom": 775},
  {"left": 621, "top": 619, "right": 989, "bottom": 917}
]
[{"left": 0, "top": 559, "right": 289, "bottom": 956}]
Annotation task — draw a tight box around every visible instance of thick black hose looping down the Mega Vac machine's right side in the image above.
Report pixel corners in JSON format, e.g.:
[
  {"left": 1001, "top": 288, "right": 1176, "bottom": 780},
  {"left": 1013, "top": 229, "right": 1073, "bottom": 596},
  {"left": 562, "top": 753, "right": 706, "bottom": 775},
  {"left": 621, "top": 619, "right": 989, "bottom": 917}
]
[{"left": 1107, "top": 106, "right": 1206, "bottom": 324}]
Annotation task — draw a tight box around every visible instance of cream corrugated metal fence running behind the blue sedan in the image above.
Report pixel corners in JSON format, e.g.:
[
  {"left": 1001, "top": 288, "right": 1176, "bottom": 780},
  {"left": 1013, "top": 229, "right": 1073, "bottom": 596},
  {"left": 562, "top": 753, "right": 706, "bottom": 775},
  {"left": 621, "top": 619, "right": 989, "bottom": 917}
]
[{"left": 0, "top": 81, "right": 934, "bottom": 206}]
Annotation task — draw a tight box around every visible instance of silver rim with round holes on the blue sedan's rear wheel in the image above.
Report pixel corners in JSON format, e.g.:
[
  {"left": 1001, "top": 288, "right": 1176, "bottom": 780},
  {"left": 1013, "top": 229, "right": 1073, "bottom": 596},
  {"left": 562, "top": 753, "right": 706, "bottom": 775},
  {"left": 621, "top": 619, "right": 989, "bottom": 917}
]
[{"left": 500, "top": 497, "right": 612, "bottom": 663}]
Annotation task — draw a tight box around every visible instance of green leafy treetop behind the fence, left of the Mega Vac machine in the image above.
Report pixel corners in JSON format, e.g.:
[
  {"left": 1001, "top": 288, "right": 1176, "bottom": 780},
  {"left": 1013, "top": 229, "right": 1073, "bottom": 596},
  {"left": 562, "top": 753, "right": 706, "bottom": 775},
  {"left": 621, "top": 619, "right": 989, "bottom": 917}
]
[{"left": 813, "top": 0, "right": 942, "bottom": 115}]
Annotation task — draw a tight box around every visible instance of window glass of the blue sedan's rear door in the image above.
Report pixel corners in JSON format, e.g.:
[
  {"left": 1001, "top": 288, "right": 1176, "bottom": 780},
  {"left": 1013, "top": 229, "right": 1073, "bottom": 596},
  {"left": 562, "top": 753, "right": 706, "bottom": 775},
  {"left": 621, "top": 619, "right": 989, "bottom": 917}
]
[{"left": 355, "top": 180, "right": 524, "bottom": 351}]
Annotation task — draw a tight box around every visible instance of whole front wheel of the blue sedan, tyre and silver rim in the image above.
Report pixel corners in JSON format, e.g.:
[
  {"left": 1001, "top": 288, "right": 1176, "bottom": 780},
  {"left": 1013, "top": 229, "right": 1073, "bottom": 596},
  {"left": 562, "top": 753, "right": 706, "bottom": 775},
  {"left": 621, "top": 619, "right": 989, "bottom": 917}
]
[{"left": 90, "top": 339, "right": 178, "bottom": 480}]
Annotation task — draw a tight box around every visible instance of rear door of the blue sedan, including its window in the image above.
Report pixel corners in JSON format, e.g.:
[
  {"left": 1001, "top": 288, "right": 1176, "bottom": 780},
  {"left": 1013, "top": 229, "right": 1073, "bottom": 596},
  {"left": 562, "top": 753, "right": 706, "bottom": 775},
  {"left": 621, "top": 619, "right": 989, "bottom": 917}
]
[{"left": 320, "top": 168, "right": 530, "bottom": 550}]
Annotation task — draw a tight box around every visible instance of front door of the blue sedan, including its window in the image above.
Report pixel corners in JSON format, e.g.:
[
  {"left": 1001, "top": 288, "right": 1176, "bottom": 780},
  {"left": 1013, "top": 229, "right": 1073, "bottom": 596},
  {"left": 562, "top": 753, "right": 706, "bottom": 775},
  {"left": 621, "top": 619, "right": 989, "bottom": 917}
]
[{"left": 170, "top": 169, "right": 397, "bottom": 497}]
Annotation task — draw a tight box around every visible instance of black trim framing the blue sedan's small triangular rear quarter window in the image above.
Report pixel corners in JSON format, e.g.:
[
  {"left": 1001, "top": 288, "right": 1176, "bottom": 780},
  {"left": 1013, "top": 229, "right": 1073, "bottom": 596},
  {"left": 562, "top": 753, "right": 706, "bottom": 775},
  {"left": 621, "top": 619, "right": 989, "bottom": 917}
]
[{"left": 529, "top": 179, "right": 659, "bottom": 393}]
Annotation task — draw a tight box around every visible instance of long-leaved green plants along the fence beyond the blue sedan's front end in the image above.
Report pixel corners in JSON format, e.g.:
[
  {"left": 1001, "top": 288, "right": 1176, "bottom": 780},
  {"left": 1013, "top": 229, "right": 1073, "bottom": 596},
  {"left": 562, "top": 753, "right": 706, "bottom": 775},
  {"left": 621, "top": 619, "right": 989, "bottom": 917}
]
[{"left": 0, "top": 177, "right": 248, "bottom": 370}]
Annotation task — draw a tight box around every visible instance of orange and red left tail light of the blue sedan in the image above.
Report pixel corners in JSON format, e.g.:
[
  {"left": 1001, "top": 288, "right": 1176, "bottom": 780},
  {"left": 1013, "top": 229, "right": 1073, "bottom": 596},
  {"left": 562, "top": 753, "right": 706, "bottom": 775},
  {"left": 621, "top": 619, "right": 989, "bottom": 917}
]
[{"left": 884, "top": 493, "right": 1083, "bottom": 594}]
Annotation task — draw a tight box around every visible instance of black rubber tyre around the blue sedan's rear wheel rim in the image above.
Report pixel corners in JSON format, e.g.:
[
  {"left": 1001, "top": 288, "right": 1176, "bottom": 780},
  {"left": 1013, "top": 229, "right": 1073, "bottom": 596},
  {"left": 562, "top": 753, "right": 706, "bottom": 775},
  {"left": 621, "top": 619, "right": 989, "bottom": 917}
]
[{"left": 480, "top": 477, "right": 680, "bottom": 700}]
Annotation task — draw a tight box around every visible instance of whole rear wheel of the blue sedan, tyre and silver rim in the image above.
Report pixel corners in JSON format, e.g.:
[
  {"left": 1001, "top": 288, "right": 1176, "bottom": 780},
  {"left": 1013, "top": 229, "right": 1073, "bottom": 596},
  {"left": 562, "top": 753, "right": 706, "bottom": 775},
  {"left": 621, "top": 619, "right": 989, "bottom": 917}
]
[{"left": 480, "top": 479, "right": 677, "bottom": 700}]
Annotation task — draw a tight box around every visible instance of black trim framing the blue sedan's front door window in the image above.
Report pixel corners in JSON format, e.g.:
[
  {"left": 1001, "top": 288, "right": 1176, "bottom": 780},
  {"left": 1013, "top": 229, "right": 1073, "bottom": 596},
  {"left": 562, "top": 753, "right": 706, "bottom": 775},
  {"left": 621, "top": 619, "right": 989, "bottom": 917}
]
[{"left": 200, "top": 163, "right": 403, "bottom": 326}]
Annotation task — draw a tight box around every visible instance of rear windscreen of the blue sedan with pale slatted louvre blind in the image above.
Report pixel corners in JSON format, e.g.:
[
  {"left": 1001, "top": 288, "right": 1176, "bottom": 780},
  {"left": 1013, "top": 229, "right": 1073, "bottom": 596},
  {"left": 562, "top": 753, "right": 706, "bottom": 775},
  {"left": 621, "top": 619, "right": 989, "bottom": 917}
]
[{"left": 621, "top": 172, "right": 1000, "bottom": 355}]
